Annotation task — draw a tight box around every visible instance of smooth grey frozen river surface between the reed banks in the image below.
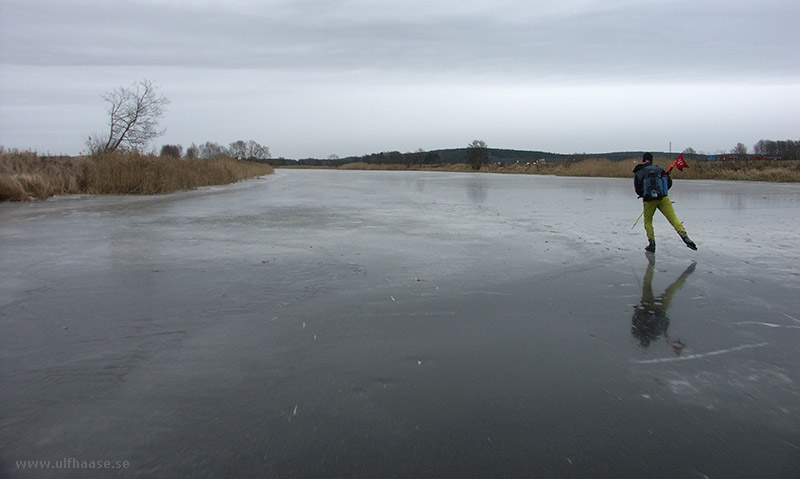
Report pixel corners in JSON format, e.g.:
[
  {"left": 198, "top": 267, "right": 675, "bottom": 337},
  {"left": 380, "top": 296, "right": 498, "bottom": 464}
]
[{"left": 0, "top": 170, "right": 800, "bottom": 479}]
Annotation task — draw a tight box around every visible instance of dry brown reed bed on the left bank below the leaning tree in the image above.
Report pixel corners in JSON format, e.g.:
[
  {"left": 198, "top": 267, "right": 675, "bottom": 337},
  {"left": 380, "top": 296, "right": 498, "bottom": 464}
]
[{"left": 0, "top": 152, "right": 274, "bottom": 201}]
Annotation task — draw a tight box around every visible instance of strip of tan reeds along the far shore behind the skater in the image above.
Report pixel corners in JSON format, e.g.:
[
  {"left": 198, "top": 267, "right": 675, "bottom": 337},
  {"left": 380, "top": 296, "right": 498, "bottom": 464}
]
[{"left": 338, "top": 159, "right": 800, "bottom": 182}]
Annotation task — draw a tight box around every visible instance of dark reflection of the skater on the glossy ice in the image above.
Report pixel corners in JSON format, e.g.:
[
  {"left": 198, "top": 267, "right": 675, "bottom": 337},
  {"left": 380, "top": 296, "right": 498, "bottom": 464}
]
[{"left": 631, "top": 253, "right": 697, "bottom": 355}]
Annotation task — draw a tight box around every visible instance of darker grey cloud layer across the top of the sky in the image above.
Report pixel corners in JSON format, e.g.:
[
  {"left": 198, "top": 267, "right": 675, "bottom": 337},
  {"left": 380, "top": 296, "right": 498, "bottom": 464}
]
[{"left": 7, "top": 0, "right": 800, "bottom": 78}]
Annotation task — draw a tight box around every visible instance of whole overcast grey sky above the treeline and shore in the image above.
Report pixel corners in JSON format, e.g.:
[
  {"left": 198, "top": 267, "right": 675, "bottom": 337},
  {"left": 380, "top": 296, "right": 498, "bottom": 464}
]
[{"left": 0, "top": 0, "right": 800, "bottom": 158}]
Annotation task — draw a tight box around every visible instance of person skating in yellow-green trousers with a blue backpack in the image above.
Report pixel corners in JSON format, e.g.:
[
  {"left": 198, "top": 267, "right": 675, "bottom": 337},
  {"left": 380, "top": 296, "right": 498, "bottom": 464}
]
[{"left": 633, "top": 153, "right": 697, "bottom": 253}]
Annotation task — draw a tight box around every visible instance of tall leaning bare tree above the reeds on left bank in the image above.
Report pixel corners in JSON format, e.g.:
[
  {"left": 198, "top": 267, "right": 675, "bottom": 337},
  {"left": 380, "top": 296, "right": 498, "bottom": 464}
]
[{"left": 86, "top": 80, "right": 169, "bottom": 153}]
